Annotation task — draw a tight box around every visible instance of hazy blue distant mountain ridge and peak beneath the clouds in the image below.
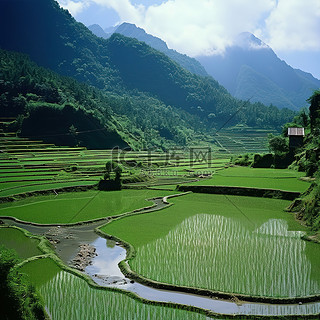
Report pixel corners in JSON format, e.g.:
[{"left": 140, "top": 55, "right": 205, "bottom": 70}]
[{"left": 89, "top": 23, "right": 320, "bottom": 110}]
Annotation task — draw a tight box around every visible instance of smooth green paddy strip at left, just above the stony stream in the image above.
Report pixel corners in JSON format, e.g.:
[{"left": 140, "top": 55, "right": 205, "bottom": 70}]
[{"left": 0, "top": 190, "right": 175, "bottom": 224}]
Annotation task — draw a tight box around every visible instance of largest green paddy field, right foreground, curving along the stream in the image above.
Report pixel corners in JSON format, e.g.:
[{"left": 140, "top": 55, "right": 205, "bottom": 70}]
[{"left": 102, "top": 194, "right": 320, "bottom": 297}]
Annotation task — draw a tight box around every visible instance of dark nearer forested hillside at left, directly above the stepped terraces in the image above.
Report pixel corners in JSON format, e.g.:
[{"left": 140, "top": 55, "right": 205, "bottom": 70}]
[{"left": 0, "top": 50, "right": 209, "bottom": 148}]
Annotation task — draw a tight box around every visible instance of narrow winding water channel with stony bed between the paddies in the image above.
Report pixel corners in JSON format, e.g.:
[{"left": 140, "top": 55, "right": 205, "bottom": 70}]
[{"left": 1, "top": 196, "right": 320, "bottom": 316}]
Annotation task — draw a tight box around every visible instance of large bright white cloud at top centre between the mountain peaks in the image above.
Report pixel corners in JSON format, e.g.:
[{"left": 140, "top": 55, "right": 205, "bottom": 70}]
[{"left": 92, "top": 0, "right": 276, "bottom": 56}]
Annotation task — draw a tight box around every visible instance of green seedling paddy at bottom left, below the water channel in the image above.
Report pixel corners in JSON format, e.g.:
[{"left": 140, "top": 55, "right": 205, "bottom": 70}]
[{"left": 21, "top": 259, "right": 210, "bottom": 320}]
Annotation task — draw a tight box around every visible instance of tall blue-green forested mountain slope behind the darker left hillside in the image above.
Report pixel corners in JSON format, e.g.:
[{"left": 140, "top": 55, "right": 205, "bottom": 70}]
[{"left": 0, "top": 0, "right": 293, "bottom": 146}]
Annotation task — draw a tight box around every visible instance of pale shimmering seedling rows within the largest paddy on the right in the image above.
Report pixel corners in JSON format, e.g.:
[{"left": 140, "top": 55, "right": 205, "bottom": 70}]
[{"left": 132, "top": 214, "right": 320, "bottom": 297}]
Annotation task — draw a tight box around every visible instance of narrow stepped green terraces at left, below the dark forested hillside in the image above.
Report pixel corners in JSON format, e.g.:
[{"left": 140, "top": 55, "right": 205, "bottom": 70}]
[{"left": 0, "top": 134, "right": 229, "bottom": 197}]
